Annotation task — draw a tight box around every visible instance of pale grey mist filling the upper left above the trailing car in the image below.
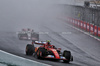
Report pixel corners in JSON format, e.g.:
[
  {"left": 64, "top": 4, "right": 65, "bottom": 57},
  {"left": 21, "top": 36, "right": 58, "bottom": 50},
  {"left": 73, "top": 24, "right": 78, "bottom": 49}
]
[{"left": 0, "top": 0, "right": 69, "bottom": 31}]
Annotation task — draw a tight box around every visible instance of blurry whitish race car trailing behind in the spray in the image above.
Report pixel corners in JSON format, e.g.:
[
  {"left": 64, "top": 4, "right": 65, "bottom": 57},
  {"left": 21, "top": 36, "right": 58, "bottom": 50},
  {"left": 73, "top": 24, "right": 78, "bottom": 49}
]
[{"left": 18, "top": 29, "right": 39, "bottom": 40}]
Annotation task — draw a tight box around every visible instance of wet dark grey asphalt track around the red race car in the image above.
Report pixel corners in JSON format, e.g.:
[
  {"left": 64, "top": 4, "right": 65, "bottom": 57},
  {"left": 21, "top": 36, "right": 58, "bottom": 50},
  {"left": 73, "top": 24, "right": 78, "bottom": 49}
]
[{"left": 0, "top": 19, "right": 100, "bottom": 66}]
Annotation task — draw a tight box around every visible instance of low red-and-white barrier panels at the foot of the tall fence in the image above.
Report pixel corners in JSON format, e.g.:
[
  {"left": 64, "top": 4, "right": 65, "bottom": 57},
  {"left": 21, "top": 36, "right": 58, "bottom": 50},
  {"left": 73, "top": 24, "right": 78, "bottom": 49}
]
[{"left": 67, "top": 17, "right": 100, "bottom": 37}]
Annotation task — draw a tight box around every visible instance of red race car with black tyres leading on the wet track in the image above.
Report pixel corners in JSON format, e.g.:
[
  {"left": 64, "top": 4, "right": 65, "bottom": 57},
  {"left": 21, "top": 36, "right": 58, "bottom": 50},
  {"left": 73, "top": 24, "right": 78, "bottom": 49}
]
[{"left": 26, "top": 41, "right": 73, "bottom": 63}]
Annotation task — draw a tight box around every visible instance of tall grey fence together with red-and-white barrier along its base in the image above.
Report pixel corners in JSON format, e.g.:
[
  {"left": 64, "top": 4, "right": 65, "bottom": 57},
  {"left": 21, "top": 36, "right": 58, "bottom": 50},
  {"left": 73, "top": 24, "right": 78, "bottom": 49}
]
[{"left": 65, "top": 5, "right": 100, "bottom": 37}]
